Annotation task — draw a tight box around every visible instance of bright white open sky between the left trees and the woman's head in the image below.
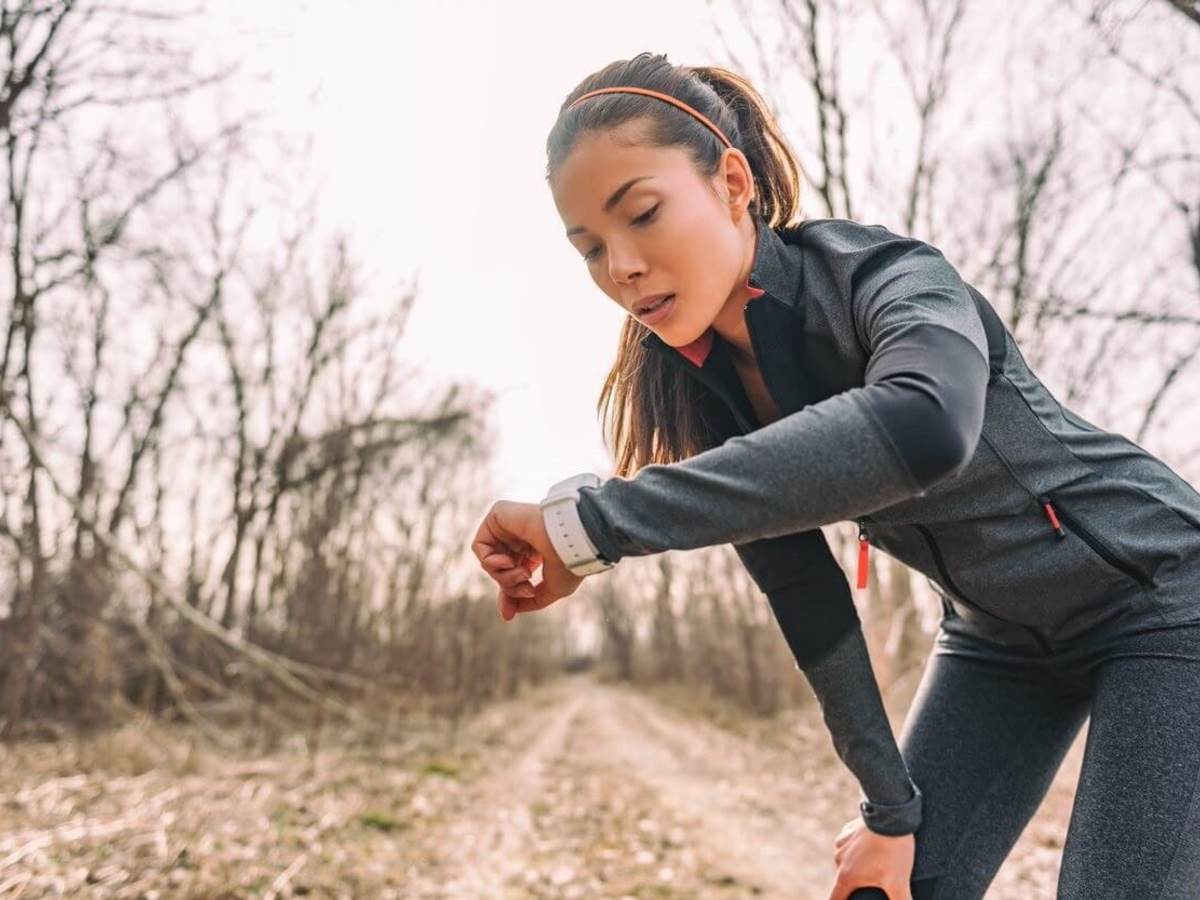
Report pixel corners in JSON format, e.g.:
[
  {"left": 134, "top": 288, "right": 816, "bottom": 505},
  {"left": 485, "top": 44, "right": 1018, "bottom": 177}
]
[{"left": 198, "top": 0, "right": 739, "bottom": 500}]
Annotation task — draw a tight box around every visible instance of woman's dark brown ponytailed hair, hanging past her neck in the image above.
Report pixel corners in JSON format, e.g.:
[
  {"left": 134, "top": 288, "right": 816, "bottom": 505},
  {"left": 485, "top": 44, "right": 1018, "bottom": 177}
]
[{"left": 546, "top": 53, "right": 802, "bottom": 476}]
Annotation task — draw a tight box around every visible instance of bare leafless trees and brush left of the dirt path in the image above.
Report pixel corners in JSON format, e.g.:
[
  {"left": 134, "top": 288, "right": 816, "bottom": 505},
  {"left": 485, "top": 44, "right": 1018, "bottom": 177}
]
[{"left": 0, "top": 0, "right": 558, "bottom": 733}]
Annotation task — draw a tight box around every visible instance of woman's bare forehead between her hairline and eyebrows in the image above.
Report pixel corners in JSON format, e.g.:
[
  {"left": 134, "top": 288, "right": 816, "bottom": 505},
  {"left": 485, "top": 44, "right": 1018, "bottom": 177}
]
[{"left": 550, "top": 132, "right": 691, "bottom": 226}]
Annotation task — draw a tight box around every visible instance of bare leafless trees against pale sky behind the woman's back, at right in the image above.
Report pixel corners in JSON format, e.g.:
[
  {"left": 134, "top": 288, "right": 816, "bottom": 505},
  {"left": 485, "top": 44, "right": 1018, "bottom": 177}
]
[{"left": 686, "top": 0, "right": 1200, "bottom": 710}]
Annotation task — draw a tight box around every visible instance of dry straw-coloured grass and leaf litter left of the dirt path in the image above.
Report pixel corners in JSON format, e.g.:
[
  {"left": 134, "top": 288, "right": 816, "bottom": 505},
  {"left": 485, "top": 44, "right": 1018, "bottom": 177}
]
[{"left": 0, "top": 720, "right": 487, "bottom": 899}]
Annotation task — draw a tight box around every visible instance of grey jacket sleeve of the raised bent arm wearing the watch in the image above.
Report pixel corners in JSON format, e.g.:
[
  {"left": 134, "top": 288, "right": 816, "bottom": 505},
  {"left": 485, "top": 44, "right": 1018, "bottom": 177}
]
[{"left": 578, "top": 220, "right": 988, "bottom": 562}]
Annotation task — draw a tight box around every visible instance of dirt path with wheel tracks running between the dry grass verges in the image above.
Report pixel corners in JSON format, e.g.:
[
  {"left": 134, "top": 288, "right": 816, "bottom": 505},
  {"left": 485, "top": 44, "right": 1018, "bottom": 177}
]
[{"left": 405, "top": 679, "right": 1086, "bottom": 900}]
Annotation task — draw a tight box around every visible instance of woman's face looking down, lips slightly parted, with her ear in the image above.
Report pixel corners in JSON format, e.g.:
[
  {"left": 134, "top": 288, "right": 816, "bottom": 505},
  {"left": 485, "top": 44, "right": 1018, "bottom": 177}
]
[{"left": 550, "top": 124, "right": 755, "bottom": 347}]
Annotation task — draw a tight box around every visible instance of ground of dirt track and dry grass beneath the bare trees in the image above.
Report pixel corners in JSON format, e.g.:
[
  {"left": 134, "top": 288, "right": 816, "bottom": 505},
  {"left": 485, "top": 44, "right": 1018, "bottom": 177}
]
[{"left": 0, "top": 677, "right": 1086, "bottom": 900}]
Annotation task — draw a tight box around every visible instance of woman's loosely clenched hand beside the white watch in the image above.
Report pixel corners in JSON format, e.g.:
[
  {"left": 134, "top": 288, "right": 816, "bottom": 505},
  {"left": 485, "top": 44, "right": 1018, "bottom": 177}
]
[{"left": 470, "top": 500, "right": 583, "bottom": 622}]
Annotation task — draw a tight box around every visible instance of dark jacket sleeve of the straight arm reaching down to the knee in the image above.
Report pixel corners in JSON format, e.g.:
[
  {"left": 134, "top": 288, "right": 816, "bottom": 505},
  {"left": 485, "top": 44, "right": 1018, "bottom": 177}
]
[{"left": 733, "top": 528, "right": 923, "bottom": 835}]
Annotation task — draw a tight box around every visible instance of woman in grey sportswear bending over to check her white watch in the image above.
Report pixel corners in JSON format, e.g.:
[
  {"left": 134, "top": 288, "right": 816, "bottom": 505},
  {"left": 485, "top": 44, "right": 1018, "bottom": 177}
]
[{"left": 473, "top": 54, "right": 1200, "bottom": 900}]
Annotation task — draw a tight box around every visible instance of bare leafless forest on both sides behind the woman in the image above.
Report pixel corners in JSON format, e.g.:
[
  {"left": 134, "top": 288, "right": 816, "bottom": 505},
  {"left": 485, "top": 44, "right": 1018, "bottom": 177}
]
[{"left": 0, "top": 0, "right": 1200, "bottom": 743}]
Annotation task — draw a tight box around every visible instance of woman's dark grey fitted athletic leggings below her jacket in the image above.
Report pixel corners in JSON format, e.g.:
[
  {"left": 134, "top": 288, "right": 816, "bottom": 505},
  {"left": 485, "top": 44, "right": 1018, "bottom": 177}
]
[{"left": 900, "top": 612, "right": 1200, "bottom": 900}]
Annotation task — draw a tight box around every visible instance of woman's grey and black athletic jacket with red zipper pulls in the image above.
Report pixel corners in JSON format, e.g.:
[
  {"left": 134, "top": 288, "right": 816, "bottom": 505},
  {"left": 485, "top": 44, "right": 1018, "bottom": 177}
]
[{"left": 568, "top": 217, "right": 1200, "bottom": 834}]
